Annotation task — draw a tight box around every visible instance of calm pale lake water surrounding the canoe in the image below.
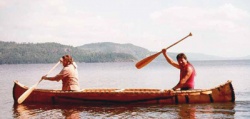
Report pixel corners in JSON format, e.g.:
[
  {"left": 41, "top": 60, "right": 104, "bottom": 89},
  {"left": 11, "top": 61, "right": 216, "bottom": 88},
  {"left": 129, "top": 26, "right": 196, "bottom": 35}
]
[{"left": 0, "top": 60, "right": 250, "bottom": 119}]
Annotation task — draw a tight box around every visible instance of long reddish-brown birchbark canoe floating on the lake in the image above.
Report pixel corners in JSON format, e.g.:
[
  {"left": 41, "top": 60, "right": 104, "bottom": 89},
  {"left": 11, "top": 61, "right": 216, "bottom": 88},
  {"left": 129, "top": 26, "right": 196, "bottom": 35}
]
[{"left": 13, "top": 81, "right": 235, "bottom": 104}]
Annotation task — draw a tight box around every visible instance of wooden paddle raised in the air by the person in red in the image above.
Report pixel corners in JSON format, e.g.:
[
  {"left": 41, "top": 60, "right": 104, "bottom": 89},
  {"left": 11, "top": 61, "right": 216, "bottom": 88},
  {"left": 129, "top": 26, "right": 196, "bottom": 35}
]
[{"left": 135, "top": 33, "right": 192, "bottom": 69}]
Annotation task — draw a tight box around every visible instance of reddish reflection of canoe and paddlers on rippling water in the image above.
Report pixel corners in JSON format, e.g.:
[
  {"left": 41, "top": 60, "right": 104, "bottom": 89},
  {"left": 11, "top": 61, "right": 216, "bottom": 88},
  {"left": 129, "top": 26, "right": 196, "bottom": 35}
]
[{"left": 13, "top": 102, "right": 235, "bottom": 119}]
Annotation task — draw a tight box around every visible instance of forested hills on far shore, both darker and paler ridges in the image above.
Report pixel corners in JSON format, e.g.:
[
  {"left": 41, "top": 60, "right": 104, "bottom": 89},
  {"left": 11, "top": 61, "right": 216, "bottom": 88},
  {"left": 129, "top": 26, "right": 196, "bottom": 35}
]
[{"left": 0, "top": 41, "right": 150, "bottom": 64}]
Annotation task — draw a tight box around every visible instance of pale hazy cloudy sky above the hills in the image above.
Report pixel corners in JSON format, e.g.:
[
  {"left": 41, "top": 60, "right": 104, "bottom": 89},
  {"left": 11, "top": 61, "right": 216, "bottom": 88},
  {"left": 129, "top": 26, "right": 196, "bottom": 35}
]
[{"left": 0, "top": 0, "right": 250, "bottom": 57}]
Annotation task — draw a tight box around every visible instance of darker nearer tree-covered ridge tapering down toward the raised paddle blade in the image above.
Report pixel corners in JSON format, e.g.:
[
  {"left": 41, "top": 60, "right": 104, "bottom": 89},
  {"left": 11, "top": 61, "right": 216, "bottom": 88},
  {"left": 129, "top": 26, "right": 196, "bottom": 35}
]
[{"left": 0, "top": 41, "right": 136, "bottom": 64}]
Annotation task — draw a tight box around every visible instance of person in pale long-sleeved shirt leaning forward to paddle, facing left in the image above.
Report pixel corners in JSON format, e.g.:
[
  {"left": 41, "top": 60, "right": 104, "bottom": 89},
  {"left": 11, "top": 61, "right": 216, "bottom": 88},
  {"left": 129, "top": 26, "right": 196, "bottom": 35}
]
[{"left": 42, "top": 55, "right": 80, "bottom": 91}]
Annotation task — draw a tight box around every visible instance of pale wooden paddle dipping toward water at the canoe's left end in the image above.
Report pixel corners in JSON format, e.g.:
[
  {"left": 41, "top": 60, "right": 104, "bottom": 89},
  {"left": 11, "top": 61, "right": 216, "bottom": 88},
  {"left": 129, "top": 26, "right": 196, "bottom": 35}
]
[{"left": 17, "top": 61, "right": 60, "bottom": 104}]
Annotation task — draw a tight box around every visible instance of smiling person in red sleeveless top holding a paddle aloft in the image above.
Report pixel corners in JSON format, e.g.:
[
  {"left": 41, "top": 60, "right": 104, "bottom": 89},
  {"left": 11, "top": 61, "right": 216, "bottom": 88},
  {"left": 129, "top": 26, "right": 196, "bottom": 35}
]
[{"left": 162, "top": 49, "right": 196, "bottom": 90}]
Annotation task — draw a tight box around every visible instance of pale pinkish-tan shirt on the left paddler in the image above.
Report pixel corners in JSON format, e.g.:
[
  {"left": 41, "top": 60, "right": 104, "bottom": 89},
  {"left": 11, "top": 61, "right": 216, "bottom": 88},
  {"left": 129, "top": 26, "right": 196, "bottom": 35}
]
[{"left": 51, "top": 63, "right": 80, "bottom": 90}]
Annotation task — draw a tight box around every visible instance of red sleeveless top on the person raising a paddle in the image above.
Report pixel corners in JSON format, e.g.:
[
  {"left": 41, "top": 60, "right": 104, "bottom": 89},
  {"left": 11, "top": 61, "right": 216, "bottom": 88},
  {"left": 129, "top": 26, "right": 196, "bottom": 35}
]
[{"left": 180, "top": 63, "right": 196, "bottom": 88}]
